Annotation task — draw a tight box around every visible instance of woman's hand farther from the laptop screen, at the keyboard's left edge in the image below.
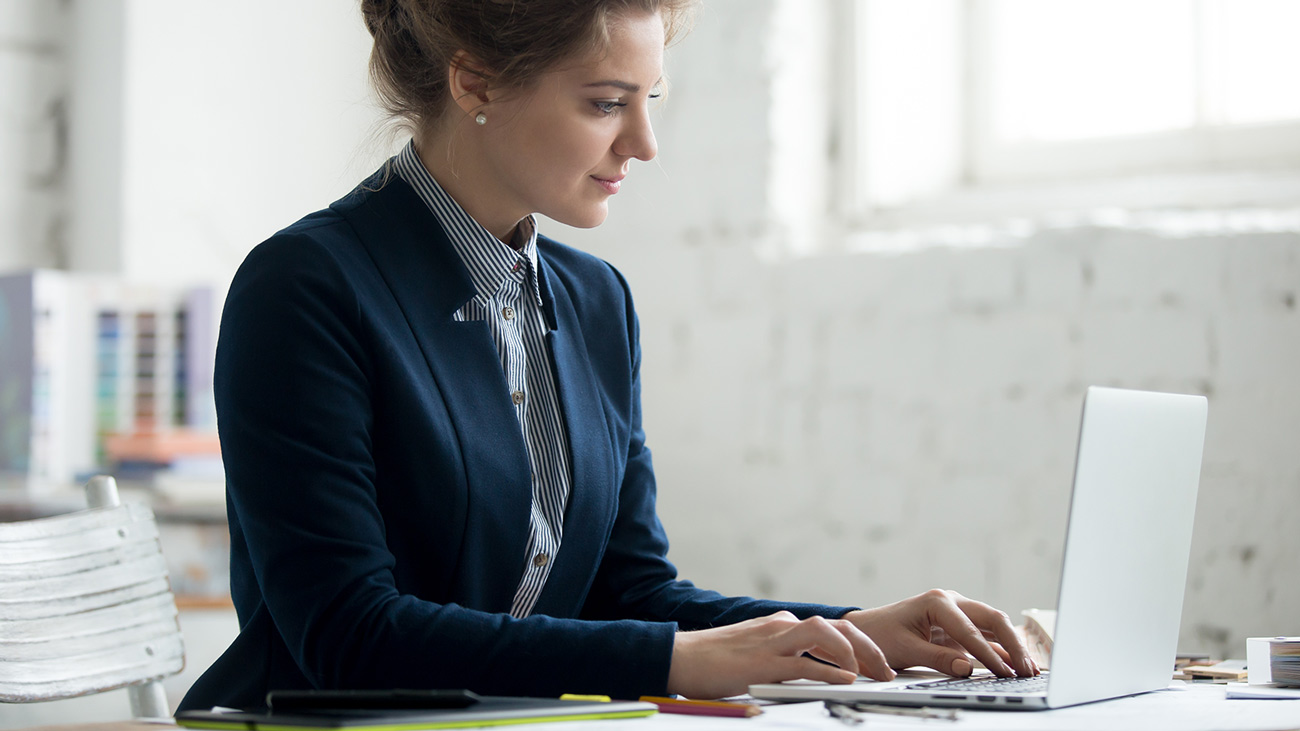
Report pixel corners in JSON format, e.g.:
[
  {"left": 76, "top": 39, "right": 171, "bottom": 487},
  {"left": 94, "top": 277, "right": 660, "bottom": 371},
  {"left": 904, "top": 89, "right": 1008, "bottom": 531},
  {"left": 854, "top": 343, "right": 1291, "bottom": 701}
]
[{"left": 668, "top": 611, "right": 894, "bottom": 698}]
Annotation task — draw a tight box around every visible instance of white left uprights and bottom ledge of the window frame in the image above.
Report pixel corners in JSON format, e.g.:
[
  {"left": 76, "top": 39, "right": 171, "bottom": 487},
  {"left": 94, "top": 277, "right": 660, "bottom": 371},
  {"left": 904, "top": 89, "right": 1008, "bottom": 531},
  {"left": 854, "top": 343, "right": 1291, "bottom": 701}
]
[{"left": 831, "top": 0, "right": 1300, "bottom": 226}]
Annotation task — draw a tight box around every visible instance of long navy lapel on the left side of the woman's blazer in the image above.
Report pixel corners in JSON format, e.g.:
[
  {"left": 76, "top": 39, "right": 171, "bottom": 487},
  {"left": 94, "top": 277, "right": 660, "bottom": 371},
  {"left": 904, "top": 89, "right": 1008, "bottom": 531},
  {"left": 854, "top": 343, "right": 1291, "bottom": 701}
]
[{"left": 334, "top": 173, "right": 532, "bottom": 611}]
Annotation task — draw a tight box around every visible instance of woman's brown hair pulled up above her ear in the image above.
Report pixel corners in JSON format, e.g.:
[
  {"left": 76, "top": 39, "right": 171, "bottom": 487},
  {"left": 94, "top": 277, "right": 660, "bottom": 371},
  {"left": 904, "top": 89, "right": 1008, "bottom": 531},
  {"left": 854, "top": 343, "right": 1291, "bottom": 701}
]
[{"left": 361, "top": 0, "right": 694, "bottom": 129}]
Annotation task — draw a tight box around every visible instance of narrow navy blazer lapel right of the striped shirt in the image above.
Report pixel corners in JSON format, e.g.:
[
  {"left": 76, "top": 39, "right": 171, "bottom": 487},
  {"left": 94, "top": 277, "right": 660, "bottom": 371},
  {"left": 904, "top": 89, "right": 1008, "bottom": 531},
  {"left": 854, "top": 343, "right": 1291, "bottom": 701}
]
[{"left": 533, "top": 252, "right": 619, "bottom": 617}]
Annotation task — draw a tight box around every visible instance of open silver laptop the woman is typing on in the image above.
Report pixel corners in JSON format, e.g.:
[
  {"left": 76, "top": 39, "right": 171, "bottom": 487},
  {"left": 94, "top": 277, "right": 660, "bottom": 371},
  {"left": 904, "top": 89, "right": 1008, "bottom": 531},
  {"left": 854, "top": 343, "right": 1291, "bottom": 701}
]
[{"left": 749, "top": 386, "right": 1208, "bottom": 710}]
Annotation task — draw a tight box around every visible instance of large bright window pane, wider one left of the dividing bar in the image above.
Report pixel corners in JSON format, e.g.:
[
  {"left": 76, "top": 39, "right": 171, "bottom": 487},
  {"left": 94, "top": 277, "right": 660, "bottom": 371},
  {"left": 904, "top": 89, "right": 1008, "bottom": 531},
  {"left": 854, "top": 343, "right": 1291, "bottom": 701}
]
[{"left": 989, "top": 0, "right": 1196, "bottom": 142}]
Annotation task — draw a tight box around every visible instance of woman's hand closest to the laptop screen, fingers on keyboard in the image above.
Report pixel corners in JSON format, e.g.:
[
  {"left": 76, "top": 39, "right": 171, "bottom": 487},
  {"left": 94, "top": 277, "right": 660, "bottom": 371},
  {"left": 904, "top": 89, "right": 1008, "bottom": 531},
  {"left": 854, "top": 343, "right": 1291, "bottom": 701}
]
[{"left": 844, "top": 589, "right": 1039, "bottom": 678}]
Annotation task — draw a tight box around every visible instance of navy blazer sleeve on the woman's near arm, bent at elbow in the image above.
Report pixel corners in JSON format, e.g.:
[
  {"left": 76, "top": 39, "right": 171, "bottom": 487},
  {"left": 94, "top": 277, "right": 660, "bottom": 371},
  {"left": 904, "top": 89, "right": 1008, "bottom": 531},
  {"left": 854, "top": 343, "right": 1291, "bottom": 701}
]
[{"left": 215, "top": 232, "right": 676, "bottom": 697}]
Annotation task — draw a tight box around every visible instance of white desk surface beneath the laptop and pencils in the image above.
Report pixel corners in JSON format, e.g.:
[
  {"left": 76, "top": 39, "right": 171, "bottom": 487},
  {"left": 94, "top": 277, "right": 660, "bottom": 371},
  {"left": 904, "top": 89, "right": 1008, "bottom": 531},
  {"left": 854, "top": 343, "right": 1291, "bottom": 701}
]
[{"left": 15, "top": 684, "right": 1300, "bottom": 731}]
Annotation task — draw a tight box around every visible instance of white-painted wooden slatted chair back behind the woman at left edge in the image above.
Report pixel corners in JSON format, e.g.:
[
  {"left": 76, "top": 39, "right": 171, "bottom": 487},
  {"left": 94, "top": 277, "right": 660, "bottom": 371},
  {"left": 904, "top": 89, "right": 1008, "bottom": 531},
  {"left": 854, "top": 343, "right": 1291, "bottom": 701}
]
[{"left": 0, "top": 477, "right": 185, "bottom": 718}]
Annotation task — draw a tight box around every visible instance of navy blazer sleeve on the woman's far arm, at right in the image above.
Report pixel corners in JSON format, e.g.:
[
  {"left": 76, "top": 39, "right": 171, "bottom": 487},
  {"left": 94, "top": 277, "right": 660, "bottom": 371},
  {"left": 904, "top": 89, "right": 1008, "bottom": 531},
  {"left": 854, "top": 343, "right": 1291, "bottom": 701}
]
[{"left": 582, "top": 261, "right": 857, "bottom": 630}]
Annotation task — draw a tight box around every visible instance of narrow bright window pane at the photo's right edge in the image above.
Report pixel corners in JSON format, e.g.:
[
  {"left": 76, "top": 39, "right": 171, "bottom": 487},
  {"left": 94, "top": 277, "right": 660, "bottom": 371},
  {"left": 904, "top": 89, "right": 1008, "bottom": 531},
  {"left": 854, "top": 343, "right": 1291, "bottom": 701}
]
[{"left": 1212, "top": 0, "right": 1300, "bottom": 124}]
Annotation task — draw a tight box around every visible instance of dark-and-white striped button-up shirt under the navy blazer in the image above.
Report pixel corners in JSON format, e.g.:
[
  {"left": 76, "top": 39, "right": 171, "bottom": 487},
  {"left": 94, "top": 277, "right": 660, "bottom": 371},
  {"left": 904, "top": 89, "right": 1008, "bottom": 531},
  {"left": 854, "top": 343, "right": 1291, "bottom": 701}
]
[{"left": 394, "top": 140, "right": 571, "bottom": 617}]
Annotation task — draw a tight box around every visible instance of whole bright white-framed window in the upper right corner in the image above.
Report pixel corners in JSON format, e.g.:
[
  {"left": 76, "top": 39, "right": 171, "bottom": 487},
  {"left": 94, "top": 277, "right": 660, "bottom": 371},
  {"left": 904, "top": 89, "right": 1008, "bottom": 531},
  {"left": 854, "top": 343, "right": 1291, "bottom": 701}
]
[{"left": 837, "top": 0, "right": 1300, "bottom": 216}]
